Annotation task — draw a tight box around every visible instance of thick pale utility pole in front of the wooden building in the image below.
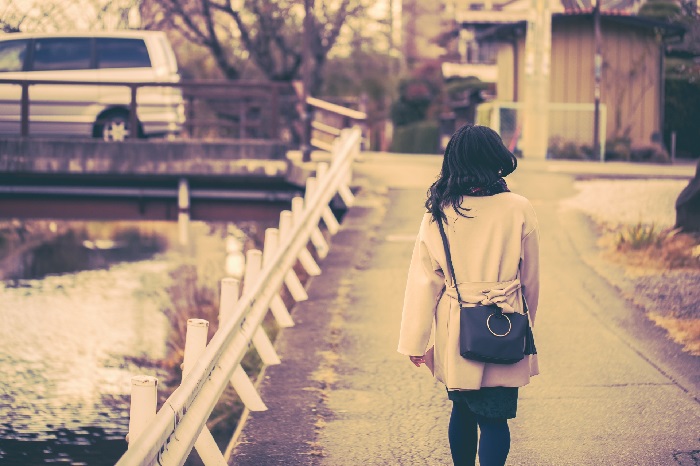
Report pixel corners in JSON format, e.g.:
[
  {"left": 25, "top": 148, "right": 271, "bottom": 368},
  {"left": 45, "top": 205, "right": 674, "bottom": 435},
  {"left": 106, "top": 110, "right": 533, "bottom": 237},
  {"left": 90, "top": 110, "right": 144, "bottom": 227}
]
[{"left": 522, "top": 0, "right": 552, "bottom": 159}]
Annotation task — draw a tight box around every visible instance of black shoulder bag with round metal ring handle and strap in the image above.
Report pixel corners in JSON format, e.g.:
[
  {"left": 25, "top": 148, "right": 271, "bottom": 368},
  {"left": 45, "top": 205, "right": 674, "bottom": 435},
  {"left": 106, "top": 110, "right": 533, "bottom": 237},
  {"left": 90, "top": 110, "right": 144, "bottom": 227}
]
[{"left": 438, "top": 221, "right": 537, "bottom": 364}]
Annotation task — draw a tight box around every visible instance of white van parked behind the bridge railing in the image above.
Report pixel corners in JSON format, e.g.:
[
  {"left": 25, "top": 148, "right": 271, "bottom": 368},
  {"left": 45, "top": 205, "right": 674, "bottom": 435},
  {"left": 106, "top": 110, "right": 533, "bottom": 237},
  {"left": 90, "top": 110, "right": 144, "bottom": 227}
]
[{"left": 0, "top": 31, "right": 185, "bottom": 141}]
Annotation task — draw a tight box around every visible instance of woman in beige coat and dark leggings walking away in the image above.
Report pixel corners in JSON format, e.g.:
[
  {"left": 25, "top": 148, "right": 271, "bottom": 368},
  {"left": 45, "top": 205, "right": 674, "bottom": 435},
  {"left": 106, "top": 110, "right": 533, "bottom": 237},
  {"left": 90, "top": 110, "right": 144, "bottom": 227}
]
[{"left": 398, "top": 125, "right": 539, "bottom": 466}]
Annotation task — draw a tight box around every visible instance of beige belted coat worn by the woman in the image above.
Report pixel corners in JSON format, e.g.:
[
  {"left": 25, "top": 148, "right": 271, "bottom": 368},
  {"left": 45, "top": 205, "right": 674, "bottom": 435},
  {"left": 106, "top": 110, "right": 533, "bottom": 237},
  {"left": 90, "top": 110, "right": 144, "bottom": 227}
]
[{"left": 398, "top": 192, "right": 539, "bottom": 390}]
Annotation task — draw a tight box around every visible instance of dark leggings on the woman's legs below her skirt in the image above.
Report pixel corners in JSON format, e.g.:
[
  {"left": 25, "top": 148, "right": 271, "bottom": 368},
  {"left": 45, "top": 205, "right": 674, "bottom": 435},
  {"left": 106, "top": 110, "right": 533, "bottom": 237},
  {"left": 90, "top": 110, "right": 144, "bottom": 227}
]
[{"left": 449, "top": 402, "right": 510, "bottom": 466}]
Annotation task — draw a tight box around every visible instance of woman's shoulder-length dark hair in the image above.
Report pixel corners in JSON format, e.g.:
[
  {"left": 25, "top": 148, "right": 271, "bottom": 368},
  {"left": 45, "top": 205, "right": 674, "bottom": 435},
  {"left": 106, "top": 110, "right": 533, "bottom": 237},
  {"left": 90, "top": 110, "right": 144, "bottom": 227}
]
[{"left": 425, "top": 125, "right": 518, "bottom": 221}]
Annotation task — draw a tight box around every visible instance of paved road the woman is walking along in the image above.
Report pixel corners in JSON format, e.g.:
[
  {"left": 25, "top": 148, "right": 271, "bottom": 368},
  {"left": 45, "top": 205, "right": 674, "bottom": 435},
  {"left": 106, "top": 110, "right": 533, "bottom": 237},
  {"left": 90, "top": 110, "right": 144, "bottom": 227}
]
[{"left": 231, "top": 155, "right": 700, "bottom": 466}]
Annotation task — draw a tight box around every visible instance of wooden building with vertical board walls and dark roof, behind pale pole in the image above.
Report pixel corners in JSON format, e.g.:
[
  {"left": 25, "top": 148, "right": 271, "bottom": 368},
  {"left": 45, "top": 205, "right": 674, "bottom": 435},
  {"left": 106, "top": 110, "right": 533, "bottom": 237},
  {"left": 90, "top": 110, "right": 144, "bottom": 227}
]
[{"left": 488, "top": 10, "right": 683, "bottom": 150}]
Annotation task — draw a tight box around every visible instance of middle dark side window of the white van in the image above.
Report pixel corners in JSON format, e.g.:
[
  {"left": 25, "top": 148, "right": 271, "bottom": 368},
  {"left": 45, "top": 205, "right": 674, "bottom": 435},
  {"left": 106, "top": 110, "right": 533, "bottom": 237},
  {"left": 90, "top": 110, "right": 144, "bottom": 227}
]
[{"left": 33, "top": 38, "right": 92, "bottom": 71}]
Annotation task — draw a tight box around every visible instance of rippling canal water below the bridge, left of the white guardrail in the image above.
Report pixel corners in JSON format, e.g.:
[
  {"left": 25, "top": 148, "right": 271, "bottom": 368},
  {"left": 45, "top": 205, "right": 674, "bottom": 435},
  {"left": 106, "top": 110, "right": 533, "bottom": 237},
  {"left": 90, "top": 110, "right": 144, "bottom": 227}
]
[{"left": 0, "top": 221, "right": 239, "bottom": 466}]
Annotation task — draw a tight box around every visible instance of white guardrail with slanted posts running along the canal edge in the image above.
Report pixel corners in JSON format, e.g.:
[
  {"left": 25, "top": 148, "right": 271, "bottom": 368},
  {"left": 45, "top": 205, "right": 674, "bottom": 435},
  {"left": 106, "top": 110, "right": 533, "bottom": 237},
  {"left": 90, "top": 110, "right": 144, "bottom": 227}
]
[{"left": 117, "top": 128, "right": 361, "bottom": 466}]
